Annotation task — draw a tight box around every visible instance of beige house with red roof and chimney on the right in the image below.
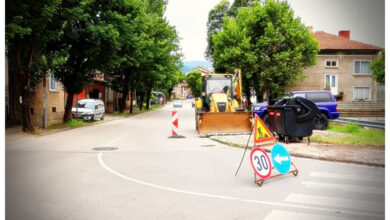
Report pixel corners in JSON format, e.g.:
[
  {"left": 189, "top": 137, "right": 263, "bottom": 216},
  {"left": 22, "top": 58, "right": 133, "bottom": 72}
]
[{"left": 288, "top": 31, "right": 384, "bottom": 102}]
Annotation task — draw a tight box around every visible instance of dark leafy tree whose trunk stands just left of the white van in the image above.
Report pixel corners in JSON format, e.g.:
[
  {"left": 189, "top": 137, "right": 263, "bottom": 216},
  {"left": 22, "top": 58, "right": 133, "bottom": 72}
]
[{"left": 53, "top": 0, "right": 134, "bottom": 122}]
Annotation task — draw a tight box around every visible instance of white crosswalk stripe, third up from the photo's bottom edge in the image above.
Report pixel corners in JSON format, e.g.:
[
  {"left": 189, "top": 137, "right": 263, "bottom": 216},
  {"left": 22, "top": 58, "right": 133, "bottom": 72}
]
[{"left": 302, "top": 181, "right": 385, "bottom": 195}]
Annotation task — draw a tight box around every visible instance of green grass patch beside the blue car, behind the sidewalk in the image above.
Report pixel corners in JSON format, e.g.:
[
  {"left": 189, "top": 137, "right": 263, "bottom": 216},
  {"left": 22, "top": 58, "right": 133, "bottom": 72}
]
[{"left": 311, "top": 124, "right": 385, "bottom": 146}]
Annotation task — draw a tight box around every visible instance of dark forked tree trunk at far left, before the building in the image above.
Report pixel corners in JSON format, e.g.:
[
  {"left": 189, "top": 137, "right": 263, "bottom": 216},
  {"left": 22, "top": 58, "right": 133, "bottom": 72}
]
[{"left": 16, "top": 48, "right": 34, "bottom": 132}]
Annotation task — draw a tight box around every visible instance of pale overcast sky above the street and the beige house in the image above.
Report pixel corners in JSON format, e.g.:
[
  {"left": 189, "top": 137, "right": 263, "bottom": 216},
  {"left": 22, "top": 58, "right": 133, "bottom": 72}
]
[{"left": 166, "top": 0, "right": 385, "bottom": 61}]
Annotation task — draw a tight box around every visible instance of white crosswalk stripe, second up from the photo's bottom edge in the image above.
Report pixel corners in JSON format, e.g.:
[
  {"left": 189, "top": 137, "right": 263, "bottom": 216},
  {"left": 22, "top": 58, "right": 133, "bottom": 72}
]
[{"left": 284, "top": 193, "right": 385, "bottom": 213}]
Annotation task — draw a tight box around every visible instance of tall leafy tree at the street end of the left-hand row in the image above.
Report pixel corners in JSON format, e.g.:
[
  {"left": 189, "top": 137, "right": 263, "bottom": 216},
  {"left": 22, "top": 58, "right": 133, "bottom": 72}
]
[{"left": 107, "top": 0, "right": 181, "bottom": 113}]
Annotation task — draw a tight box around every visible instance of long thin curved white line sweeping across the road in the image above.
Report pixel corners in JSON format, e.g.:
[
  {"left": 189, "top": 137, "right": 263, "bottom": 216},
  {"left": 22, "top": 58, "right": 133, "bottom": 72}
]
[{"left": 97, "top": 152, "right": 384, "bottom": 217}]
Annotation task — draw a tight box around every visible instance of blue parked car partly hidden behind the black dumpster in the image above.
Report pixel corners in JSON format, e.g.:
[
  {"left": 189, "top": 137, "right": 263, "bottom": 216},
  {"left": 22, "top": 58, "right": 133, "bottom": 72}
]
[{"left": 252, "top": 90, "right": 340, "bottom": 130}]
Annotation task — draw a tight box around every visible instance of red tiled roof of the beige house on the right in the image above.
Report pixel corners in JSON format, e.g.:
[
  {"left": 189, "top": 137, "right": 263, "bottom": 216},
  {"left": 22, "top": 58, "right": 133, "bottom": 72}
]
[{"left": 313, "top": 31, "right": 382, "bottom": 50}]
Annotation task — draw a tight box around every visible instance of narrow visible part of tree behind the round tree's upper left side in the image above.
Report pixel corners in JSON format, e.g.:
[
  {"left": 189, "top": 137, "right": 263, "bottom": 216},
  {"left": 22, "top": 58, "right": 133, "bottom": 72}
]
[{"left": 205, "top": 0, "right": 229, "bottom": 60}]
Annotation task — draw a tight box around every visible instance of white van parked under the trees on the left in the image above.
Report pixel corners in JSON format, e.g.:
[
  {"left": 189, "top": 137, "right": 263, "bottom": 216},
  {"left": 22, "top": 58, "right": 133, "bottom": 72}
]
[{"left": 72, "top": 99, "right": 105, "bottom": 121}]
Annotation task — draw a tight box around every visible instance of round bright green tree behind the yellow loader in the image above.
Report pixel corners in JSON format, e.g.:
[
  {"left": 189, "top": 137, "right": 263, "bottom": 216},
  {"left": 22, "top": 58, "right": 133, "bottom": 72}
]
[{"left": 212, "top": 0, "right": 319, "bottom": 100}]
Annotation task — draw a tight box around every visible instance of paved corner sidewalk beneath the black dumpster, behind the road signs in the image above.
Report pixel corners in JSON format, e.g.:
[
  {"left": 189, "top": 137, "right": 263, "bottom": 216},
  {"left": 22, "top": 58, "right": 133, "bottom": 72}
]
[{"left": 210, "top": 131, "right": 385, "bottom": 167}]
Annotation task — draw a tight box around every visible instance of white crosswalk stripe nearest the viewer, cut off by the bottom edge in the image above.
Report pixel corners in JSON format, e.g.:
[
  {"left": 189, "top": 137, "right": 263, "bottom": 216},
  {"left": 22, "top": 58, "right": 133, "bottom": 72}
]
[{"left": 263, "top": 210, "right": 349, "bottom": 220}]
